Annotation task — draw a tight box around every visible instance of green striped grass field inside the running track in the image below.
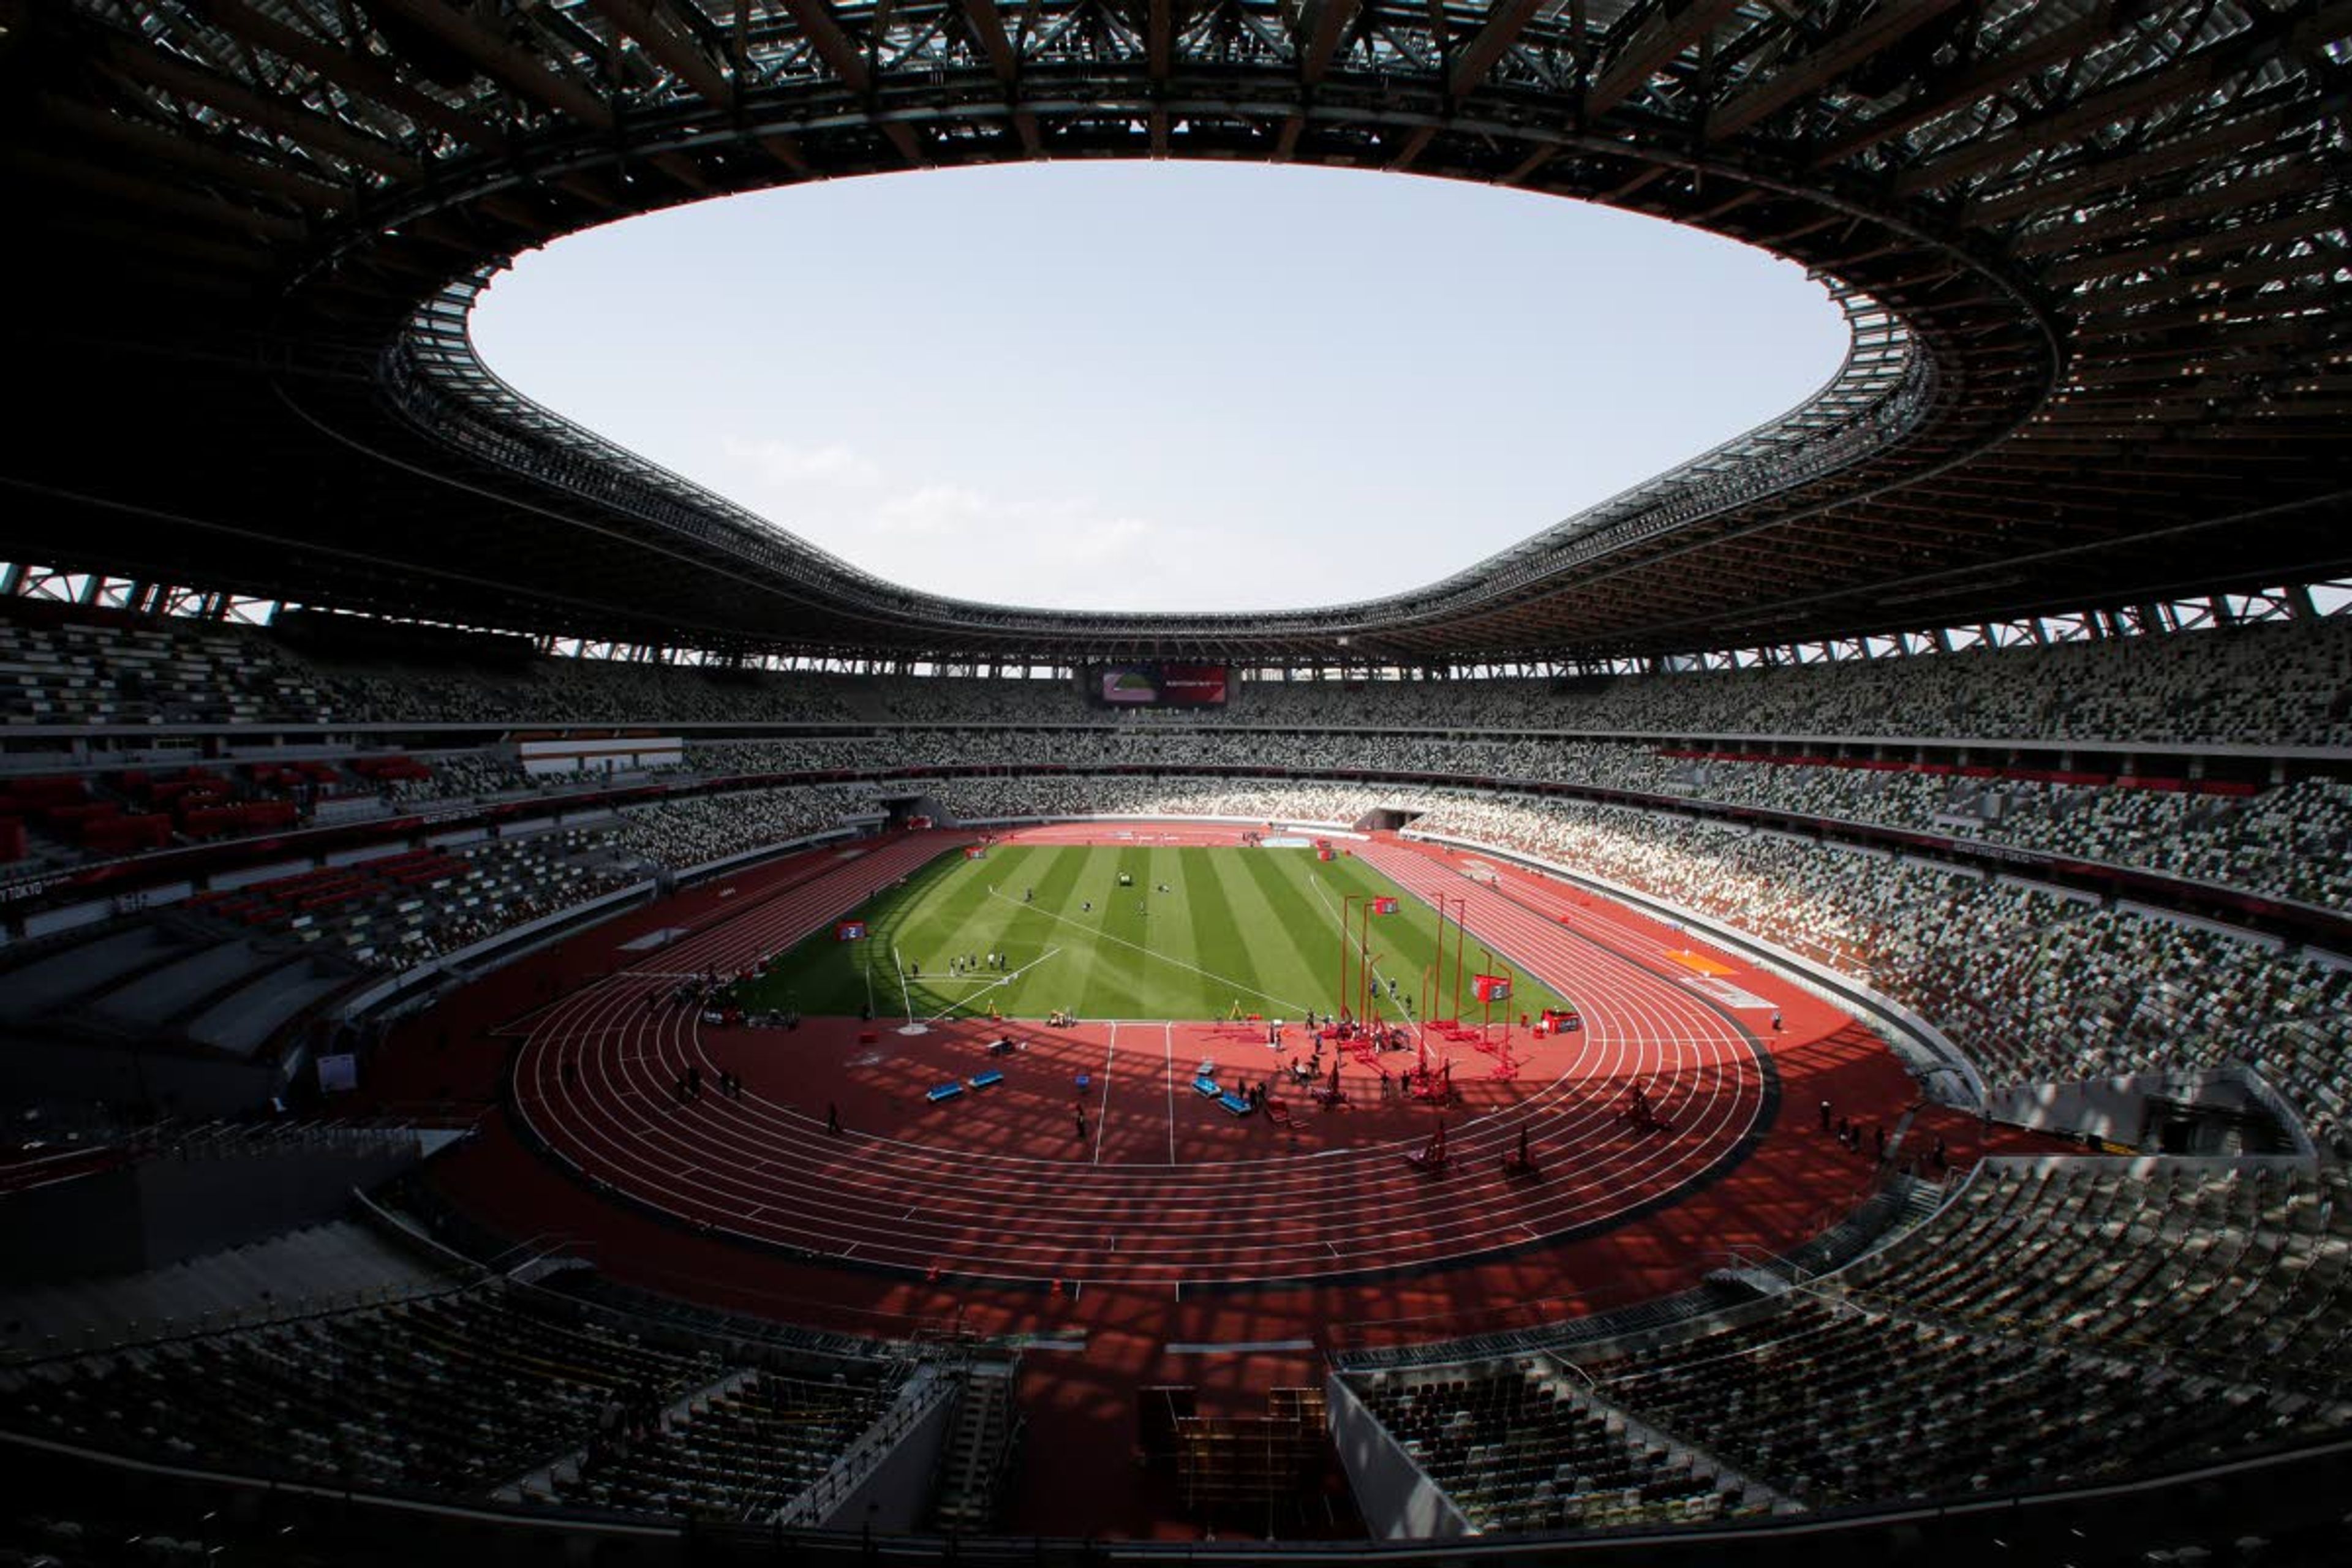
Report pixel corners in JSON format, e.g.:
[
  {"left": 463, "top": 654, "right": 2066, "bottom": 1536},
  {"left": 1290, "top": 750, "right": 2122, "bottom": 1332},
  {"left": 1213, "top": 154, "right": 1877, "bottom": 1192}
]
[{"left": 736, "top": 844, "right": 1559, "bottom": 1018}]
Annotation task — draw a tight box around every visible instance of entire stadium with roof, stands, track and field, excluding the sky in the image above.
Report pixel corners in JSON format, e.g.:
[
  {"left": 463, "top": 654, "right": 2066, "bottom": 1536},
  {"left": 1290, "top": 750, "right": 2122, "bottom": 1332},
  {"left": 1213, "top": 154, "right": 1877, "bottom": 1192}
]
[{"left": 0, "top": 0, "right": 2352, "bottom": 1568}]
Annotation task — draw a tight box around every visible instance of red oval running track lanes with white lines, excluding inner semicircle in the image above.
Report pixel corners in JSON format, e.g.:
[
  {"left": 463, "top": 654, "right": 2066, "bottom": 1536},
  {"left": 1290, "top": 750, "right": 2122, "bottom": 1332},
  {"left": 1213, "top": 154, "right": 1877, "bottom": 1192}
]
[{"left": 515, "top": 835, "right": 1773, "bottom": 1295}]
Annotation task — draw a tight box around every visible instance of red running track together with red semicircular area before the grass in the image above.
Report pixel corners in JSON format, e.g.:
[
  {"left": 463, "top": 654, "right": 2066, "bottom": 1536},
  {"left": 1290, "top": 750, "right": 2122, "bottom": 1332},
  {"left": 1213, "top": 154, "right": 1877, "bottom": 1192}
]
[{"left": 515, "top": 827, "right": 1776, "bottom": 1298}]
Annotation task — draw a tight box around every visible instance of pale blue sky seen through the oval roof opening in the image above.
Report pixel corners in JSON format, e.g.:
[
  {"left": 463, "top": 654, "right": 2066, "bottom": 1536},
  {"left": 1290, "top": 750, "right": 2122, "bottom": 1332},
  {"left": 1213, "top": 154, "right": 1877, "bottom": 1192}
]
[{"left": 473, "top": 162, "right": 1846, "bottom": 611}]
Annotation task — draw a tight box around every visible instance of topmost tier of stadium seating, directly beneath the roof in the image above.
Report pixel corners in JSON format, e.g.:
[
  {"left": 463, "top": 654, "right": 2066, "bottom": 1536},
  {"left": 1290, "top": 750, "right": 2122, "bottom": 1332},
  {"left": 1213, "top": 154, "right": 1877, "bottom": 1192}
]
[{"left": 0, "top": 614, "right": 2352, "bottom": 748}]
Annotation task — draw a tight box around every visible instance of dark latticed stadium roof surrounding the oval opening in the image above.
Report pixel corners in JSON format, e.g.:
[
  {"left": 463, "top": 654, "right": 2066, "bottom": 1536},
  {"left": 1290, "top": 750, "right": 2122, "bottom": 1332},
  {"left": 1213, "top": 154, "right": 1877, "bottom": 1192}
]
[{"left": 0, "top": 0, "right": 2352, "bottom": 663}]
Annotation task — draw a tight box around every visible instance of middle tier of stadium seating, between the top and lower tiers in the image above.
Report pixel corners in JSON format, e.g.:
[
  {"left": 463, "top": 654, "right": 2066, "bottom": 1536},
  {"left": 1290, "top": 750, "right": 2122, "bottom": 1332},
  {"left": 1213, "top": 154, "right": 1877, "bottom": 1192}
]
[{"left": 23, "top": 726, "right": 2352, "bottom": 907}]
